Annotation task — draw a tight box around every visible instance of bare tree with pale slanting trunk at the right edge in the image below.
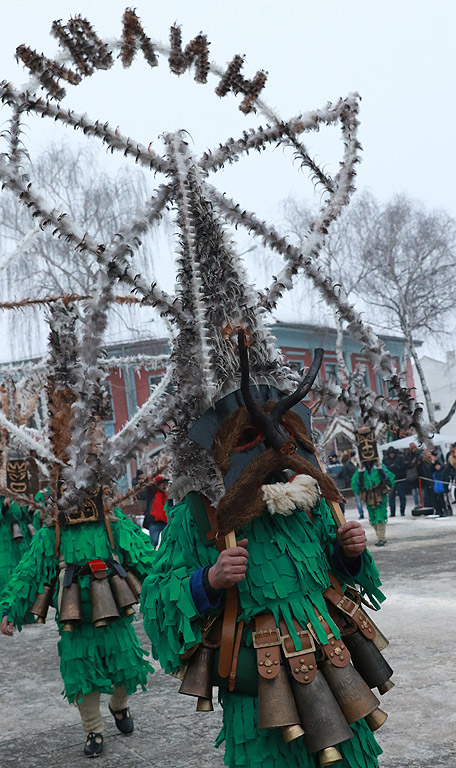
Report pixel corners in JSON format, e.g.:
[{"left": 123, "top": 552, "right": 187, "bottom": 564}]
[{"left": 354, "top": 195, "right": 456, "bottom": 431}]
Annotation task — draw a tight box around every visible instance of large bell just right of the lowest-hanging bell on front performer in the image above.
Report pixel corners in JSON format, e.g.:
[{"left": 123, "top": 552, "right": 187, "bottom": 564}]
[{"left": 320, "top": 660, "right": 379, "bottom": 723}]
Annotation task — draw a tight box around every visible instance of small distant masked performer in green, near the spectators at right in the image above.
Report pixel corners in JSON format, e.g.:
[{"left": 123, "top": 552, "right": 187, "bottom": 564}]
[{"left": 351, "top": 427, "right": 394, "bottom": 547}]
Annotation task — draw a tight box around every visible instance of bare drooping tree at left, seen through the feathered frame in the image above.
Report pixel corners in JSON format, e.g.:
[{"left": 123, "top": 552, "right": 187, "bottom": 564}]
[{"left": 0, "top": 144, "right": 166, "bottom": 354}]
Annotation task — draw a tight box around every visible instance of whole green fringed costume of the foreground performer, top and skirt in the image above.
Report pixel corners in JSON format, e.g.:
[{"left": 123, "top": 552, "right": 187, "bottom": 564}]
[{"left": 142, "top": 493, "right": 383, "bottom": 768}]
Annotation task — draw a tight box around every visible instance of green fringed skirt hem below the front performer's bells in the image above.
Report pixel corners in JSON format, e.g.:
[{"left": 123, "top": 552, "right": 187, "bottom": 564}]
[{"left": 216, "top": 691, "right": 382, "bottom": 768}]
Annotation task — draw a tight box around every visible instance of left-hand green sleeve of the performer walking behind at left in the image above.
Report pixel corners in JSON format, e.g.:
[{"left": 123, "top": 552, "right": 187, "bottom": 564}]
[{"left": 0, "top": 528, "right": 57, "bottom": 630}]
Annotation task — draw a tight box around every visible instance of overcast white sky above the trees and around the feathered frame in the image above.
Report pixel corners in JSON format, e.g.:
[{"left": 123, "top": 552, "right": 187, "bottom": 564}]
[{"left": 0, "top": 0, "right": 456, "bottom": 360}]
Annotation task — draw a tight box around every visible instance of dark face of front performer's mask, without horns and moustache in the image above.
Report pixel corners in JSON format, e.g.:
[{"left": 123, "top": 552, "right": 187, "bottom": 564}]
[{"left": 189, "top": 385, "right": 318, "bottom": 490}]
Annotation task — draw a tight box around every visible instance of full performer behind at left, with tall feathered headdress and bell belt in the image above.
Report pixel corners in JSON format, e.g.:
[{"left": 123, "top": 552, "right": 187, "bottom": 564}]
[{"left": 0, "top": 307, "right": 155, "bottom": 757}]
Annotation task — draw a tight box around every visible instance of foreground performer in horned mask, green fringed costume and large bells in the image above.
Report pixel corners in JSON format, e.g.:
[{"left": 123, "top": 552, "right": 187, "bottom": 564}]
[{"left": 142, "top": 330, "right": 392, "bottom": 768}]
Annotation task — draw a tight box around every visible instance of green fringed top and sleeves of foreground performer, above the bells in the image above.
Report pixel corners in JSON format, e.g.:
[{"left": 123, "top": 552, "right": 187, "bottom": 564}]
[{"left": 141, "top": 493, "right": 384, "bottom": 672}]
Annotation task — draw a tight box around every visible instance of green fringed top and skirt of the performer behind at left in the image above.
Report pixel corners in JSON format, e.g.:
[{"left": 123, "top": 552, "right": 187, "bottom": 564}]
[{"left": 0, "top": 510, "right": 155, "bottom": 702}]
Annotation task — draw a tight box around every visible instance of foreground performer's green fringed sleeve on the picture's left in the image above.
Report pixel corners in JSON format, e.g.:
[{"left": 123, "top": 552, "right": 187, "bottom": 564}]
[{"left": 141, "top": 493, "right": 218, "bottom": 673}]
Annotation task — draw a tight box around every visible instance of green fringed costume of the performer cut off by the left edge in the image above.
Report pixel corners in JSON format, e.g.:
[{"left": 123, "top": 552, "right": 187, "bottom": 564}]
[{"left": 0, "top": 496, "right": 32, "bottom": 593}]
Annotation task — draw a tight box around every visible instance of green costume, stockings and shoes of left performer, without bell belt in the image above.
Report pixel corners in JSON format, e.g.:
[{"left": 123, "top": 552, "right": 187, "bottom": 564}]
[{"left": 0, "top": 510, "right": 155, "bottom": 756}]
